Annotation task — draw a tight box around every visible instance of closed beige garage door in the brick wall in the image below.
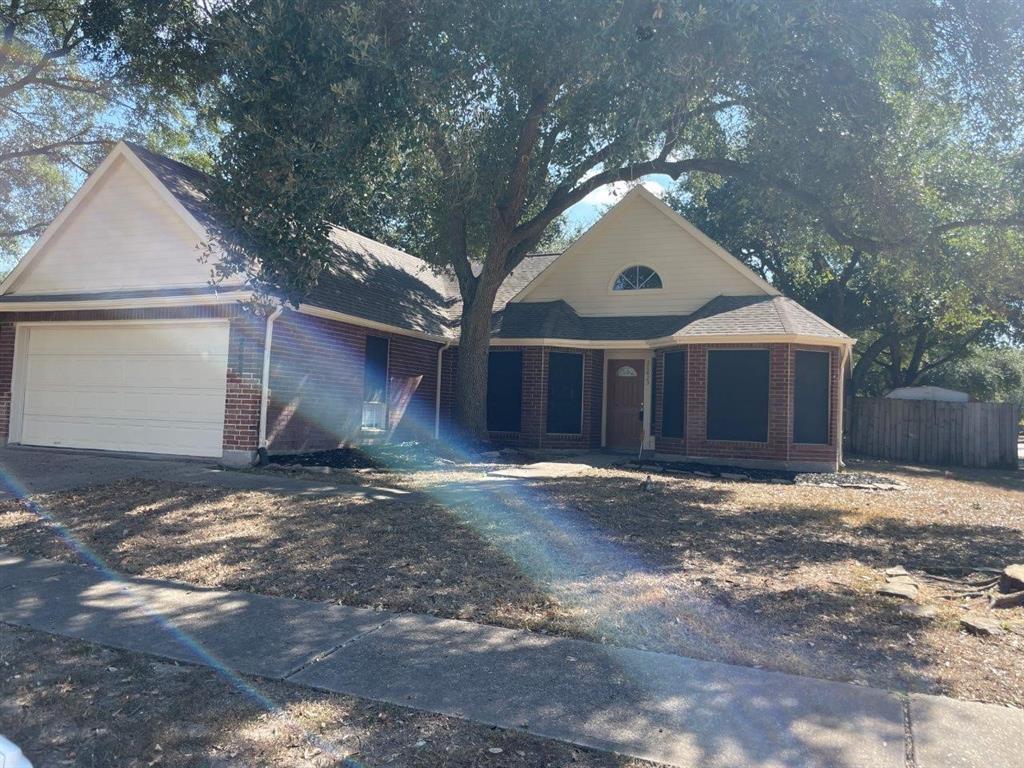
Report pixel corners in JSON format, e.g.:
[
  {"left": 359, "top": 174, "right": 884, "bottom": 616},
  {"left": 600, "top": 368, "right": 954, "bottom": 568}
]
[{"left": 11, "top": 321, "right": 227, "bottom": 457}]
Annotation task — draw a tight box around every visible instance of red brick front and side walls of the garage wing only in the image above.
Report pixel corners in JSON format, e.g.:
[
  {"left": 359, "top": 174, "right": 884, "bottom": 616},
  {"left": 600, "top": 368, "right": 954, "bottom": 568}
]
[{"left": 0, "top": 304, "right": 439, "bottom": 462}]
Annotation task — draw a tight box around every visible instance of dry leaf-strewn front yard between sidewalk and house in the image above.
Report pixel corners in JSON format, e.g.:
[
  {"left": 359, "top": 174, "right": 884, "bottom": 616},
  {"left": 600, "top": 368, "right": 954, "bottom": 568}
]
[{"left": 0, "top": 456, "right": 1024, "bottom": 707}]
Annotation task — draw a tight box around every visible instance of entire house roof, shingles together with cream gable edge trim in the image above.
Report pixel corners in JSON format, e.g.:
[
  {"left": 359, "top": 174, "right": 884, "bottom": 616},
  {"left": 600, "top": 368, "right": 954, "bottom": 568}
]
[{"left": 0, "top": 142, "right": 852, "bottom": 343}]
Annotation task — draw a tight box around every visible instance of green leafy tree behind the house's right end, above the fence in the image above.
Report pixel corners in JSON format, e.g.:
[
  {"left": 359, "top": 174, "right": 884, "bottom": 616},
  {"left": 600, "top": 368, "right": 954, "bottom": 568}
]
[{"left": 669, "top": 37, "right": 1024, "bottom": 394}]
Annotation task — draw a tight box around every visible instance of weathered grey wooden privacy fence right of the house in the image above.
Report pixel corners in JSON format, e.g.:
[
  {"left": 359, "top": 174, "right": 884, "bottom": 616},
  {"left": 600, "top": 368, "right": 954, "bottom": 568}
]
[{"left": 849, "top": 397, "right": 1020, "bottom": 469}]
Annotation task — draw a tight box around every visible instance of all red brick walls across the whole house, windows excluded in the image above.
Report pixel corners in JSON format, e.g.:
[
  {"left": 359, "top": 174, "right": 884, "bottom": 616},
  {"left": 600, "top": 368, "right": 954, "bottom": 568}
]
[{"left": 0, "top": 304, "right": 843, "bottom": 467}]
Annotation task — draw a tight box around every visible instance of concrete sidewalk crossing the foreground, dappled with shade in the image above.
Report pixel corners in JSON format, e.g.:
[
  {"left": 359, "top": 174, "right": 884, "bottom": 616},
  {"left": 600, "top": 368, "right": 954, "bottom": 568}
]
[{"left": 0, "top": 551, "right": 1024, "bottom": 768}]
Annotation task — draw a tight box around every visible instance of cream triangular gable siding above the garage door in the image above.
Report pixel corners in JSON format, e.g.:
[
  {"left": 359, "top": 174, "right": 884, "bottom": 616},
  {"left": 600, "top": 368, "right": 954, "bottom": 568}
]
[{"left": 11, "top": 157, "right": 210, "bottom": 294}]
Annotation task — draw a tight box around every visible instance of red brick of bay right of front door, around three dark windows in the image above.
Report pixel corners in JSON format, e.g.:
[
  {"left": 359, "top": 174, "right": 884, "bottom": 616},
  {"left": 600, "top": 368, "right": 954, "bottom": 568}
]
[{"left": 654, "top": 344, "right": 842, "bottom": 464}]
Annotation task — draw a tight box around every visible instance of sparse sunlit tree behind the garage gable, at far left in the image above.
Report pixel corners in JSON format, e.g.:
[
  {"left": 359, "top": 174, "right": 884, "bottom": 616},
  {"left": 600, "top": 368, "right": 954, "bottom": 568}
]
[{"left": 0, "top": 0, "right": 211, "bottom": 267}]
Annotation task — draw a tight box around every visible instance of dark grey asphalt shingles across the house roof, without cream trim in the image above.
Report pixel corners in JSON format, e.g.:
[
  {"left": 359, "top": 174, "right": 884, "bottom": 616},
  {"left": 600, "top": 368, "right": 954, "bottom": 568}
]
[{"left": 117, "top": 143, "right": 848, "bottom": 341}]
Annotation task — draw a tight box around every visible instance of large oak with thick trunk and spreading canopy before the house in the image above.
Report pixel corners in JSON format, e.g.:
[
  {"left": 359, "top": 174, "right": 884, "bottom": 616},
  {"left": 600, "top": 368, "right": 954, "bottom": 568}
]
[{"left": 132, "top": 0, "right": 1024, "bottom": 436}]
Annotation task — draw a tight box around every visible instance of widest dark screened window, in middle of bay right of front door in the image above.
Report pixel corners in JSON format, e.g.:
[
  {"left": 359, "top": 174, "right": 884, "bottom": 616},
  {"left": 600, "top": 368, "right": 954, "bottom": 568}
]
[{"left": 708, "top": 349, "right": 768, "bottom": 442}]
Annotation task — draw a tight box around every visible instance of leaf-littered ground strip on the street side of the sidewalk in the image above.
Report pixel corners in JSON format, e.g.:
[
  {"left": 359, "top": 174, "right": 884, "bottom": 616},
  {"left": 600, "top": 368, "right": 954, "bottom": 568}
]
[{"left": 0, "top": 625, "right": 653, "bottom": 768}]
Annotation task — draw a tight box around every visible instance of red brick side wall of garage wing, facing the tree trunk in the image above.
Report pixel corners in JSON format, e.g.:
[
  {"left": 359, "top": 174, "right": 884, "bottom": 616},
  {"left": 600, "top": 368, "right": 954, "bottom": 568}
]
[{"left": 267, "top": 311, "right": 440, "bottom": 453}]
